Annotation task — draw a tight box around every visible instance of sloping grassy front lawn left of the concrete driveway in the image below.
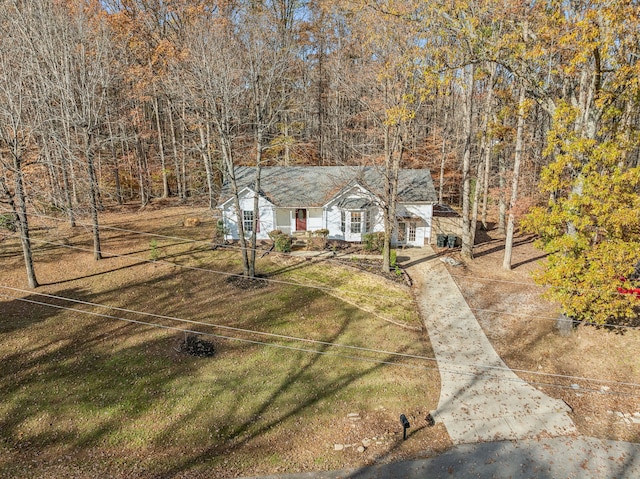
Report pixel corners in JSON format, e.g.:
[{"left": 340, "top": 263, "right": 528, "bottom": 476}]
[{"left": 0, "top": 209, "right": 447, "bottom": 477}]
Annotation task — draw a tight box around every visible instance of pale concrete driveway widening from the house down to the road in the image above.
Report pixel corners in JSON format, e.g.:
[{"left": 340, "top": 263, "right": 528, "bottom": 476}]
[{"left": 402, "top": 246, "right": 576, "bottom": 444}]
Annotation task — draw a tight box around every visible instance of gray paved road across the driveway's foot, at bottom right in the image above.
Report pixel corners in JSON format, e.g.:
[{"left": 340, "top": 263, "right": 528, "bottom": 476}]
[{"left": 242, "top": 437, "right": 640, "bottom": 479}]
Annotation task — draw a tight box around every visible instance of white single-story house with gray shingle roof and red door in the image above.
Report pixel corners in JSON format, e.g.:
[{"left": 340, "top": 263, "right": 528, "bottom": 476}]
[{"left": 218, "top": 166, "right": 437, "bottom": 246}]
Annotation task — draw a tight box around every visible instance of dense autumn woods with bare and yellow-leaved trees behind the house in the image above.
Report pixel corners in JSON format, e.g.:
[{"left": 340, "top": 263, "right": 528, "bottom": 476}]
[{"left": 0, "top": 0, "right": 640, "bottom": 319}]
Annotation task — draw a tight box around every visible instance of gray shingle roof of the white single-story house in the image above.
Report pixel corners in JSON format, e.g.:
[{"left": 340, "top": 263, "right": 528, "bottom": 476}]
[{"left": 219, "top": 166, "right": 437, "bottom": 207}]
